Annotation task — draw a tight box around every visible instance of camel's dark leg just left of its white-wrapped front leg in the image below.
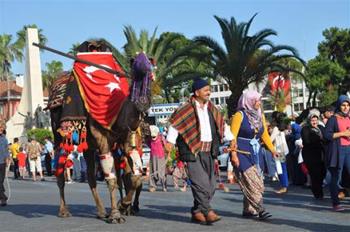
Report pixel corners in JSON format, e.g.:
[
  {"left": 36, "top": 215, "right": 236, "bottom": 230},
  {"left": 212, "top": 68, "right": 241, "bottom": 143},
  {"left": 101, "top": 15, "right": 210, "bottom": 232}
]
[{"left": 84, "top": 151, "right": 107, "bottom": 218}]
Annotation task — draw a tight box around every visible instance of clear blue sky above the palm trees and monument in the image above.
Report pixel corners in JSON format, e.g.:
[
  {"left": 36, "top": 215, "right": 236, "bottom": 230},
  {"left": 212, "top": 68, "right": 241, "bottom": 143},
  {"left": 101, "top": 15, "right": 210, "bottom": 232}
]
[{"left": 0, "top": 0, "right": 350, "bottom": 73}]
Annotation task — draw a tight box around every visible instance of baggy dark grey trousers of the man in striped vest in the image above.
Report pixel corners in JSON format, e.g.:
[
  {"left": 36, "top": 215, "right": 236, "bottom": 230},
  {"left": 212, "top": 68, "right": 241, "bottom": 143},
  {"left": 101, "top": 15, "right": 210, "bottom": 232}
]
[{"left": 187, "top": 152, "right": 216, "bottom": 215}]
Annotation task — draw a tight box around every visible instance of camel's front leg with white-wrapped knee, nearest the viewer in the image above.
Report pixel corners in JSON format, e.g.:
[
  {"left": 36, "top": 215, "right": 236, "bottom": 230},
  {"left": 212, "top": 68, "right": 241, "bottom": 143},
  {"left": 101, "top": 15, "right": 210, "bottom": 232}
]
[{"left": 100, "top": 152, "right": 125, "bottom": 224}]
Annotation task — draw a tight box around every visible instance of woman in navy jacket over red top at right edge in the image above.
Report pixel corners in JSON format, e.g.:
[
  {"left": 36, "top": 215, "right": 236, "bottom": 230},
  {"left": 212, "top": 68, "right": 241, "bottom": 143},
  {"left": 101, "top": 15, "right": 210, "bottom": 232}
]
[{"left": 324, "top": 95, "right": 350, "bottom": 212}]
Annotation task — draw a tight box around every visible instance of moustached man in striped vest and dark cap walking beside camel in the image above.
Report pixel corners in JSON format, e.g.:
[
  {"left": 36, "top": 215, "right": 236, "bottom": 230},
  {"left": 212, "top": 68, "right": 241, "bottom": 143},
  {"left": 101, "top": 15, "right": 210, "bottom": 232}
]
[{"left": 166, "top": 78, "right": 233, "bottom": 224}]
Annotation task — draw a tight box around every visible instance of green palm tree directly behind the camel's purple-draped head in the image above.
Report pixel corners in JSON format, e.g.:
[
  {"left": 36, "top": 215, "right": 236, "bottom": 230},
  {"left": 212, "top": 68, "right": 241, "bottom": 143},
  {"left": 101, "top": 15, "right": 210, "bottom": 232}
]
[{"left": 124, "top": 26, "right": 211, "bottom": 102}]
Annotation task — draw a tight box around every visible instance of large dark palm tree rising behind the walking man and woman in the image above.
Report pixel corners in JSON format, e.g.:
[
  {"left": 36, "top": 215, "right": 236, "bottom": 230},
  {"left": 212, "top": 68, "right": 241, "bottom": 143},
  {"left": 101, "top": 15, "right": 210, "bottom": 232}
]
[{"left": 194, "top": 14, "right": 304, "bottom": 116}]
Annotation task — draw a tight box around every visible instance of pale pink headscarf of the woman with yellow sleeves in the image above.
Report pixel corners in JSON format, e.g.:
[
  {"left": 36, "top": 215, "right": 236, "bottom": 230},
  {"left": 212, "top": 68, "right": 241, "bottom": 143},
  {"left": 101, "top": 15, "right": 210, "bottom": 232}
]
[{"left": 237, "top": 90, "right": 262, "bottom": 130}]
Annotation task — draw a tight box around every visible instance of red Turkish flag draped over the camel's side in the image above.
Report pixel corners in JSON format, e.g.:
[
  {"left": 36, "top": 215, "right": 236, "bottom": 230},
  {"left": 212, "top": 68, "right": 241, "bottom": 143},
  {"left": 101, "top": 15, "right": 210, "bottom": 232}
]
[{"left": 73, "top": 52, "right": 129, "bottom": 128}]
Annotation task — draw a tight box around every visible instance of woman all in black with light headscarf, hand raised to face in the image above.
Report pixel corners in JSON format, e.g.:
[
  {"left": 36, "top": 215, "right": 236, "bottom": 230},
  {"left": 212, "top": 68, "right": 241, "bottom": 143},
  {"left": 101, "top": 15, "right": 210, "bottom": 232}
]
[{"left": 301, "top": 109, "right": 326, "bottom": 199}]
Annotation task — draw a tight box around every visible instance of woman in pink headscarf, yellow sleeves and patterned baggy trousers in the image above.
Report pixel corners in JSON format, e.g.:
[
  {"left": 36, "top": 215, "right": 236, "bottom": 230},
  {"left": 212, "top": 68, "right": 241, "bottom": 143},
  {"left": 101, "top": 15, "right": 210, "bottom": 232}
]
[{"left": 231, "top": 90, "right": 276, "bottom": 220}]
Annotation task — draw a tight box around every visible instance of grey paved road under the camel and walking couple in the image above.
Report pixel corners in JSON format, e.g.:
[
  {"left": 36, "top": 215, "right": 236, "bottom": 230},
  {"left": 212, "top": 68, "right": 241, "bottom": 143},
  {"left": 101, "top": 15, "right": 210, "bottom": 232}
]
[{"left": 0, "top": 178, "right": 350, "bottom": 232}]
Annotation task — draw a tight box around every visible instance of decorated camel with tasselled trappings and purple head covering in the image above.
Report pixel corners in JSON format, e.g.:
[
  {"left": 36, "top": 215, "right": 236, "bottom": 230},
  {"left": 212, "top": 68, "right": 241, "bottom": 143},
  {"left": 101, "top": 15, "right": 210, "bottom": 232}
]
[{"left": 48, "top": 40, "right": 153, "bottom": 224}]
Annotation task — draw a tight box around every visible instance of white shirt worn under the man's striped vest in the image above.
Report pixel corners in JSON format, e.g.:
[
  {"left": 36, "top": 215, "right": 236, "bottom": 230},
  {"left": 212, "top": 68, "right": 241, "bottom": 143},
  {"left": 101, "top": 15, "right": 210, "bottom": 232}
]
[{"left": 167, "top": 101, "right": 233, "bottom": 144}]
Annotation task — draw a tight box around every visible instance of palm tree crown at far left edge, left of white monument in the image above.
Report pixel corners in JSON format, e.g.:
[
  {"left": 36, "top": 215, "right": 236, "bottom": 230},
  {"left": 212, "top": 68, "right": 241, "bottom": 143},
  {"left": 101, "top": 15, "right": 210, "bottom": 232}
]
[{"left": 0, "top": 34, "right": 23, "bottom": 81}]
